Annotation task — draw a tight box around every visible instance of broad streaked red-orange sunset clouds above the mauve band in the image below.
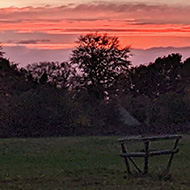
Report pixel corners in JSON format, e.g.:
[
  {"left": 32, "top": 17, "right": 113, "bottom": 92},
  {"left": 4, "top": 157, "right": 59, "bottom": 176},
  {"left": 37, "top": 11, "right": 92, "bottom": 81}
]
[{"left": 0, "top": 1, "right": 190, "bottom": 48}]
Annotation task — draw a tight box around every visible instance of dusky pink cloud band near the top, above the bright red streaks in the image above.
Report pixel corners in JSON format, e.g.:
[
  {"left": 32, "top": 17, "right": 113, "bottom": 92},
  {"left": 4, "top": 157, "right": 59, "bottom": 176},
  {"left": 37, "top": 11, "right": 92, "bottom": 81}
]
[{"left": 0, "top": 3, "right": 190, "bottom": 24}]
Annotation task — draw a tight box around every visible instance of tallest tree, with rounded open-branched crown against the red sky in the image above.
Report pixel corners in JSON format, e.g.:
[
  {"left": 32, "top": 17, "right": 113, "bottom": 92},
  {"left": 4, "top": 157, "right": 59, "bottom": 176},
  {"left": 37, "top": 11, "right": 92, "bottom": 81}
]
[{"left": 70, "top": 33, "right": 130, "bottom": 99}]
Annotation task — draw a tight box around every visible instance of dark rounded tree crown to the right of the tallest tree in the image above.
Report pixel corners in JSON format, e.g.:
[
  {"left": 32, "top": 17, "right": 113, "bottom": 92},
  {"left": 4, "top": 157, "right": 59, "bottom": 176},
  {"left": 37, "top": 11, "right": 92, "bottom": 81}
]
[{"left": 130, "top": 54, "right": 182, "bottom": 98}]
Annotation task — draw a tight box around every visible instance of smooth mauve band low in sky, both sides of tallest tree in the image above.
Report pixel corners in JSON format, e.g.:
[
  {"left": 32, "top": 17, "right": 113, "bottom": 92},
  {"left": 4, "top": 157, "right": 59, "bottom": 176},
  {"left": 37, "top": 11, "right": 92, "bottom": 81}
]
[{"left": 3, "top": 46, "right": 190, "bottom": 67}]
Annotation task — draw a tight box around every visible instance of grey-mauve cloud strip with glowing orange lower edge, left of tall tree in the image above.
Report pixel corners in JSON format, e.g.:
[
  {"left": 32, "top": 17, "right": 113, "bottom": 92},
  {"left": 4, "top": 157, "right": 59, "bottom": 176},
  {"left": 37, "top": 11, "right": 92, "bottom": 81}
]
[{"left": 0, "top": 31, "right": 79, "bottom": 49}]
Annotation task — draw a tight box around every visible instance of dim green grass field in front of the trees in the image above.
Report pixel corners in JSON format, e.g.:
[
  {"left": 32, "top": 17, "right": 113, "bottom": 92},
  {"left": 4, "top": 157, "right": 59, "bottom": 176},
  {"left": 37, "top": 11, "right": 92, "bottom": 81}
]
[{"left": 0, "top": 136, "right": 190, "bottom": 190}]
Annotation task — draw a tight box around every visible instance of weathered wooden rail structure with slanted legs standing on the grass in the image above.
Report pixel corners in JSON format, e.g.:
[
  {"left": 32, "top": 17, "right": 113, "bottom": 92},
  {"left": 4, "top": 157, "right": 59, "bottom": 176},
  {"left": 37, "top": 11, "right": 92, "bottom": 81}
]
[{"left": 118, "top": 135, "right": 182, "bottom": 174}]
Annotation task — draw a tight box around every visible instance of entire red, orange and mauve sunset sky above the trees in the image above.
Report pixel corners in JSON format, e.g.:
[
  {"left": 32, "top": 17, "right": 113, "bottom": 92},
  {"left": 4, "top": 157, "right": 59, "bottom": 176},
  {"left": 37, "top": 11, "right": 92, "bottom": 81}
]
[{"left": 0, "top": 0, "right": 190, "bottom": 66}]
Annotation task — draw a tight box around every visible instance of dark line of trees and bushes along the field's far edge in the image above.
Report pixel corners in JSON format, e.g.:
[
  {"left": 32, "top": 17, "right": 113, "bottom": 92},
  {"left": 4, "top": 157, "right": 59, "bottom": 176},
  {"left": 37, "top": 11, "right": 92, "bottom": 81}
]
[{"left": 0, "top": 34, "right": 190, "bottom": 137}]
